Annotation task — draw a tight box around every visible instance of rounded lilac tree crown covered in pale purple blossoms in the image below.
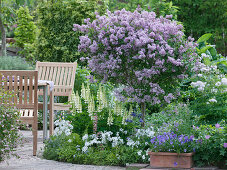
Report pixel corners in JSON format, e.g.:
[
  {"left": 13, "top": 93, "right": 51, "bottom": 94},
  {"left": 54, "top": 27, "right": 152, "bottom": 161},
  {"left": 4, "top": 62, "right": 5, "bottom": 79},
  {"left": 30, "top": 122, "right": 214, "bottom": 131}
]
[{"left": 73, "top": 9, "right": 197, "bottom": 104}]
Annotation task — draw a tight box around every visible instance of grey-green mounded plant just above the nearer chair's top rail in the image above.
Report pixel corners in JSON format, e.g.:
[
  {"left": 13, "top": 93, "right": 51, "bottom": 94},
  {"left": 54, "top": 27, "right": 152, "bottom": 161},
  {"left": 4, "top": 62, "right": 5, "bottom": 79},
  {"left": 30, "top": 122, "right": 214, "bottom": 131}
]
[{"left": 0, "top": 56, "right": 33, "bottom": 70}]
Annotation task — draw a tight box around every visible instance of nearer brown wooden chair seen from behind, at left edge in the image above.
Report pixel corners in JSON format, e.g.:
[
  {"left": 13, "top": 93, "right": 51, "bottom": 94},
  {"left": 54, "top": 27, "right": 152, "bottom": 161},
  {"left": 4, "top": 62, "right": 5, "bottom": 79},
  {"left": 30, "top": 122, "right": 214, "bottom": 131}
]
[{"left": 0, "top": 70, "right": 38, "bottom": 156}]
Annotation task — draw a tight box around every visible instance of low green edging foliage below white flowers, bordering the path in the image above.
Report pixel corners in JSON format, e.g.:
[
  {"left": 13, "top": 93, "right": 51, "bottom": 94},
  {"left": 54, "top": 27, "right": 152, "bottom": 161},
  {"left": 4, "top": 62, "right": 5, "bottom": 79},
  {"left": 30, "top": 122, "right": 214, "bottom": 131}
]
[{"left": 43, "top": 129, "right": 151, "bottom": 166}]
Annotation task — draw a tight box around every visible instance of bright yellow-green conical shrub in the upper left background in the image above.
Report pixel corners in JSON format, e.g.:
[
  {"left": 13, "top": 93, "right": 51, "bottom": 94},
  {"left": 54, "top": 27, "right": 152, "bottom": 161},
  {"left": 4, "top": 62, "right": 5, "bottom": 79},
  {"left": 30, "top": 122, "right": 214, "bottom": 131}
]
[{"left": 15, "top": 7, "right": 36, "bottom": 48}]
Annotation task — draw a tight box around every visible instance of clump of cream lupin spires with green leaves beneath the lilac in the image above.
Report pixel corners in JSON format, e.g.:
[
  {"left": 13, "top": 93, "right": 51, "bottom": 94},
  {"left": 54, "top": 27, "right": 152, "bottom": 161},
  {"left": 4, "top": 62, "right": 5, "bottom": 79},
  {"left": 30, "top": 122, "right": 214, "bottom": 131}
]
[{"left": 64, "top": 68, "right": 141, "bottom": 135}]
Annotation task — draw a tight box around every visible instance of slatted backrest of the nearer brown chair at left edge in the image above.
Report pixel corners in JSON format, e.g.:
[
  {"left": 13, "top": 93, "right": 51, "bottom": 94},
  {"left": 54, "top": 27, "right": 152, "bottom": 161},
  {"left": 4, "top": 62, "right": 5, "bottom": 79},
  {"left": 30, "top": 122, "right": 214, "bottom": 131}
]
[{"left": 0, "top": 70, "right": 38, "bottom": 110}]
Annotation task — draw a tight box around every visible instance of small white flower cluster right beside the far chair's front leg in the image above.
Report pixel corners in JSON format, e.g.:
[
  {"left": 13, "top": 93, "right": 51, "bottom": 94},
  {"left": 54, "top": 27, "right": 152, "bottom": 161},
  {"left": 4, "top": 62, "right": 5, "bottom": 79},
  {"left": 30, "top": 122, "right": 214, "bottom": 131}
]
[{"left": 54, "top": 120, "right": 73, "bottom": 136}]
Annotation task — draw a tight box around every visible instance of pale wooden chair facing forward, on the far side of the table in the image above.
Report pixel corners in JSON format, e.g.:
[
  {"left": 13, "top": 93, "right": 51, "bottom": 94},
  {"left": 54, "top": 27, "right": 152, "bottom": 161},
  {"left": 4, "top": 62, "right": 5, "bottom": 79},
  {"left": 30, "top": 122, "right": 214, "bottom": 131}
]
[{"left": 36, "top": 61, "right": 77, "bottom": 135}]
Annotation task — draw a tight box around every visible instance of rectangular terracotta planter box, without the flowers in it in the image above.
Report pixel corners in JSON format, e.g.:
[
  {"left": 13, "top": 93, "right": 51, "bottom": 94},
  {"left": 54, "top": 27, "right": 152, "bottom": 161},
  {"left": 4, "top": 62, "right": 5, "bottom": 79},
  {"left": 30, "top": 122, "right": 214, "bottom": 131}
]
[{"left": 148, "top": 152, "right": 194, "bottom": 168}]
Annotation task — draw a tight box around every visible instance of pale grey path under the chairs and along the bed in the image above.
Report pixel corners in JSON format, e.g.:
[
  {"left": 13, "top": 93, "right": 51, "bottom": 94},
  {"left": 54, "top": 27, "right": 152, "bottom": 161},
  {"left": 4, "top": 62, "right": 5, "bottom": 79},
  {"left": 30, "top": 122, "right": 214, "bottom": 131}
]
[{"left": 0, "top": 131, "right": 125, "bottom": 170}]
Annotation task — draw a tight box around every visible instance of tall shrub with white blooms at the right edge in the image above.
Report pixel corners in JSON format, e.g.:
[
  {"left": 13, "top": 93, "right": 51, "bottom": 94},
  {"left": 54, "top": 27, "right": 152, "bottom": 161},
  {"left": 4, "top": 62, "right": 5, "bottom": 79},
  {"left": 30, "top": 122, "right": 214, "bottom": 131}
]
[{"left": 188, "top": 54, "right": 227, "bottom": 123}]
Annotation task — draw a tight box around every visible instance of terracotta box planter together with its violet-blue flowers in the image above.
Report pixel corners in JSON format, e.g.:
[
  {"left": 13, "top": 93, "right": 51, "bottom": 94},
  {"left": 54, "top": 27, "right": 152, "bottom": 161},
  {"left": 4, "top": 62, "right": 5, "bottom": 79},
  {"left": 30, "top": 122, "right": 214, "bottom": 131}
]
[{"left": 148, "top": 132, "right": 201, "bottom": 168}]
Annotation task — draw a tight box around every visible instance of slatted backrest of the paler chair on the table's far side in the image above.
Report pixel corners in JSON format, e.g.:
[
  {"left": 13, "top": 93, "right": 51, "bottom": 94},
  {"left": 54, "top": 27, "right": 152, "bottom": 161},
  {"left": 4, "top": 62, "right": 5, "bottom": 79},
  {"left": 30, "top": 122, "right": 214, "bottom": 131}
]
[{"left": 36, "top": 61, "right": 77, "bottom": 97}]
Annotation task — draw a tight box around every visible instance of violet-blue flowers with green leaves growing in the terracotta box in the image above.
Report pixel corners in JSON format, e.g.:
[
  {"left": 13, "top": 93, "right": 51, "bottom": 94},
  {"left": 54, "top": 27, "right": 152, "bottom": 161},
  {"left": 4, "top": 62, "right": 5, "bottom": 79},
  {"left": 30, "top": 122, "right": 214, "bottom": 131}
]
[{"left": 151, "top": 132, "right": 202, "bottom": 153}]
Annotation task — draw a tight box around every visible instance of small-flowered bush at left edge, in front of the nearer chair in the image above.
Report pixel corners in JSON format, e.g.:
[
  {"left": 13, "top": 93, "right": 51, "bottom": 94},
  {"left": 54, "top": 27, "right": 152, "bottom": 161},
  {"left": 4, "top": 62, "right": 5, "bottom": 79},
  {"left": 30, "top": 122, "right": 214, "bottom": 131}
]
[{"left": 0, "top": 80, "right": 19, "bottom": 162}]
